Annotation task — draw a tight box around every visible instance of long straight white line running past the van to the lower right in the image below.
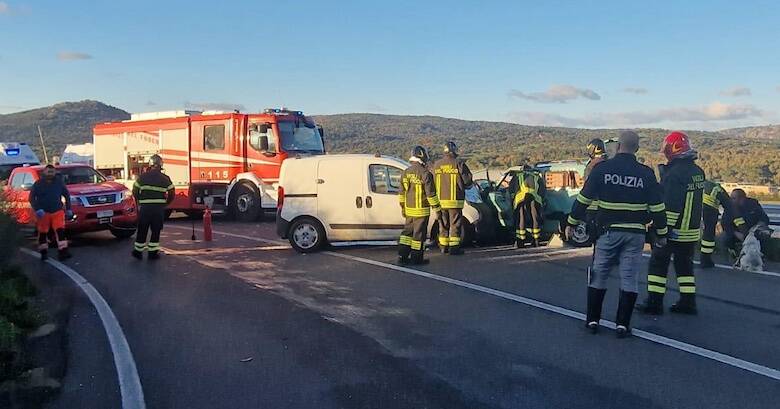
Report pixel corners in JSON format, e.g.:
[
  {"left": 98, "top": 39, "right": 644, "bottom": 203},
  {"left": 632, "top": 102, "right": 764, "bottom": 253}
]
[{"left": 183, "top": 226, "right": 780, "bottom": 381}]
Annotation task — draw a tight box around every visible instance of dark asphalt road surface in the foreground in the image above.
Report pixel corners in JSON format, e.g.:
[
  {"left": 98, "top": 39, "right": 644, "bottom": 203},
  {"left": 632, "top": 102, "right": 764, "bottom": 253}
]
[{"left": 51, "top": 221, "right": 780, "bottom": 409}]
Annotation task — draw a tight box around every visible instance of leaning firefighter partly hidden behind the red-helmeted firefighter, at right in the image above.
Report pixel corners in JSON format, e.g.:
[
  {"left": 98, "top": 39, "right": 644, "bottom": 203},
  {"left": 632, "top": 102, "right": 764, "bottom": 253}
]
[{"left": 699, "top": 180, "right": 745, "bottom": 268}]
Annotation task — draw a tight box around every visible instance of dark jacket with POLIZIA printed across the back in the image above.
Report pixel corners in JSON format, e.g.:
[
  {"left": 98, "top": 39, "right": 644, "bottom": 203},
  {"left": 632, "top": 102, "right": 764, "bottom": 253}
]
[{"left": 568, "top": 153, "right": 668, "bottom": 237}]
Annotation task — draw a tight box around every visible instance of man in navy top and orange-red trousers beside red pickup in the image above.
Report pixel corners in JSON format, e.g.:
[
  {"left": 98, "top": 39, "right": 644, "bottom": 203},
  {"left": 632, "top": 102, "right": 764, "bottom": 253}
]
[{"left": 30, "top": 165, "right": 73, "bottom": 260}]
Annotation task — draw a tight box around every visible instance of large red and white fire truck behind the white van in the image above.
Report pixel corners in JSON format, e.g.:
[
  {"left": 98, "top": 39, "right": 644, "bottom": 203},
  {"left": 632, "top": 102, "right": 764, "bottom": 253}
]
[{"left": 94, "top": 109, "right": 325, "bottom": 221}]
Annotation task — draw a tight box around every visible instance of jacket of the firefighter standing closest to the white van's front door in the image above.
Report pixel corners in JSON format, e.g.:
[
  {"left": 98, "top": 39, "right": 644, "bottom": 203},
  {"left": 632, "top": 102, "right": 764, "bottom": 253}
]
[{"left": 398, "top": 162, "right": 439, "bottom": 217}]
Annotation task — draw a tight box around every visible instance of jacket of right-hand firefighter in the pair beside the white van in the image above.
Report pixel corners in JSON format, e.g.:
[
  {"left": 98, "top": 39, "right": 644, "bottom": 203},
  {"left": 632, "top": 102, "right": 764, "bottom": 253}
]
[{"left": 433, "top": 154, "right": 473, "bottom": 209}]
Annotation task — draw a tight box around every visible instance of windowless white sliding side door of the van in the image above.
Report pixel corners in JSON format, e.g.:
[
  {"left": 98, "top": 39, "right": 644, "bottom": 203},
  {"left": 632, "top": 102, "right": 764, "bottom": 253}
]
[{"left": 317, "top": 158, "right": 367, "bottom": 241}]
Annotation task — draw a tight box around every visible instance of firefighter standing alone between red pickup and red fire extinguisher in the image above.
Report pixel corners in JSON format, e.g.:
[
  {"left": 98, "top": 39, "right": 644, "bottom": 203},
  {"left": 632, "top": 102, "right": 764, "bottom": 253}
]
[{"left": 131, "top": 155, "right": 176, "bottom": 260}]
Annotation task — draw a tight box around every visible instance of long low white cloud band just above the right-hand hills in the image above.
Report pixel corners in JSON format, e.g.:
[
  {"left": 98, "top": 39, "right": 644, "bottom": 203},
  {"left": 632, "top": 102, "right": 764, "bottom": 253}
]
[{"left": 510, "top": 102, "right": 766, "bottom": 127}]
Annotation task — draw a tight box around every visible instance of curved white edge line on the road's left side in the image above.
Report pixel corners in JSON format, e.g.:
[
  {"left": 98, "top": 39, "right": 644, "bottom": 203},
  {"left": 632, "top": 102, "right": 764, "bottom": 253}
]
[{"left": 21, "top": 248, "right": 146, "bottom": 409}]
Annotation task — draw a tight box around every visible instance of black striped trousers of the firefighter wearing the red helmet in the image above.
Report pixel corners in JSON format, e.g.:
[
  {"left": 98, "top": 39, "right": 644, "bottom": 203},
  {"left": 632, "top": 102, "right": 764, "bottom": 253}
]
[{"left": 647, "top": 241, "right": 697, "bottom": 297}]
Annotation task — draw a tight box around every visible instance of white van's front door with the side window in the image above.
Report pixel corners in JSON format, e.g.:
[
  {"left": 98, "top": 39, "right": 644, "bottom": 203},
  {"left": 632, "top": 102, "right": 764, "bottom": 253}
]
[{"left": 363, "top": 161, "right": 404, "bottom": 240}]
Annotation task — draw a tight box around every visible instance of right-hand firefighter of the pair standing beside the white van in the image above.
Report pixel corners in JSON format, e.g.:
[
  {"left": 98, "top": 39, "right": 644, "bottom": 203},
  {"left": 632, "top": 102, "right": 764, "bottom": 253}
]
[{"left": 433, "top": 141, "right": 473, "bottom": 256}]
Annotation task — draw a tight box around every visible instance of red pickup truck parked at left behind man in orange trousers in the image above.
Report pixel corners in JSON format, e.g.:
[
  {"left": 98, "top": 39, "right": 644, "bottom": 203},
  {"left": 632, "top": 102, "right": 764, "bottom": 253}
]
[{"left": 5, "top": 164, "right": 138, "bottom": 238}]
